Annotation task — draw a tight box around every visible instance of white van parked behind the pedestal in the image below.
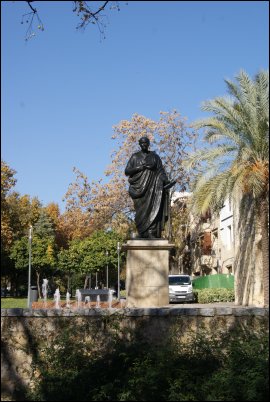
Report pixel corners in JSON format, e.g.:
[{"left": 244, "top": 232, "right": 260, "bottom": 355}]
[{"left": 169, "top": 275, "right": 194, "bottom": 302}]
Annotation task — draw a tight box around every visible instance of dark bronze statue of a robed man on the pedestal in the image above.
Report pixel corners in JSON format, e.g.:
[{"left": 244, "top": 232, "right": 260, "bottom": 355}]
[{"left": 125, "top": 137, "right": 175, "bottom": 239}]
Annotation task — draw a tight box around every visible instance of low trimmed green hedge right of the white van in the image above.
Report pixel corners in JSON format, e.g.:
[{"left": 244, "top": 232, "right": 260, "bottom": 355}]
[{"left": 193, "top": 288, "right": 234, "bottom": 303}]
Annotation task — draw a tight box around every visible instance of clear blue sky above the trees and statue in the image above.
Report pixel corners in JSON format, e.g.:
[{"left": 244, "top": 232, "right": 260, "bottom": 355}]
[{"left": 1, "top": 1, "right": 269, "bottom": 210}]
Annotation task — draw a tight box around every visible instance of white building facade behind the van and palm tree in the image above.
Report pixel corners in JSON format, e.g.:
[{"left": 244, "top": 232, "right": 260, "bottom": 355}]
[{"left": 173, "top": 193, "right": 235, "bottom": 276}]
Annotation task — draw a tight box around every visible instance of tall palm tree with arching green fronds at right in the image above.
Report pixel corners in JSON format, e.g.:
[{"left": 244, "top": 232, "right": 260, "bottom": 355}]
[{"left": 187, "top": 71, "right": 269, "bottom": 305}]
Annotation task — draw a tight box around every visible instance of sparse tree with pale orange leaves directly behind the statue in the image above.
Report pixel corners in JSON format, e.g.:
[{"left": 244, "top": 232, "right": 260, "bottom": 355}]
[{"left": 65, "top": 110, "right": 197, "bottom": 263}]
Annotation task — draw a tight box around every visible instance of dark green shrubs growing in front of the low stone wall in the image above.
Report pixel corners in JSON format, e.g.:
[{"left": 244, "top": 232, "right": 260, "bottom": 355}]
[{"left": 25, "top": 322, "right": 269, "bottom": 401}]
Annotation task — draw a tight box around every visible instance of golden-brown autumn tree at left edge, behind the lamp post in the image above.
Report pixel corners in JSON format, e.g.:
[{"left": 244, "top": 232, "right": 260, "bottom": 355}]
[{"left": 1, "top": 160, "right": 60, "bottom": 294}]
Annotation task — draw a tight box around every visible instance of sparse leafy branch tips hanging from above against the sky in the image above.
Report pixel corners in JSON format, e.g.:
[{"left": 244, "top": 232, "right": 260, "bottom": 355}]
[{"left": 21, "top": 1, "right": 124, "bottom": 41}]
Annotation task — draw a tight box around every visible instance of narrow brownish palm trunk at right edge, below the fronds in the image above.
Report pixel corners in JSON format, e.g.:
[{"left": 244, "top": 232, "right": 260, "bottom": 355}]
[{"left": 260, "top": 197, "right": 269, "bottom": 306}]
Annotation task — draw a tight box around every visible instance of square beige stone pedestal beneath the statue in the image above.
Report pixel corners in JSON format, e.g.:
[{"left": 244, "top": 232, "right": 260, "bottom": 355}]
[{"left": 122, "top": 239, "right": 174, "bottom": 307}]
